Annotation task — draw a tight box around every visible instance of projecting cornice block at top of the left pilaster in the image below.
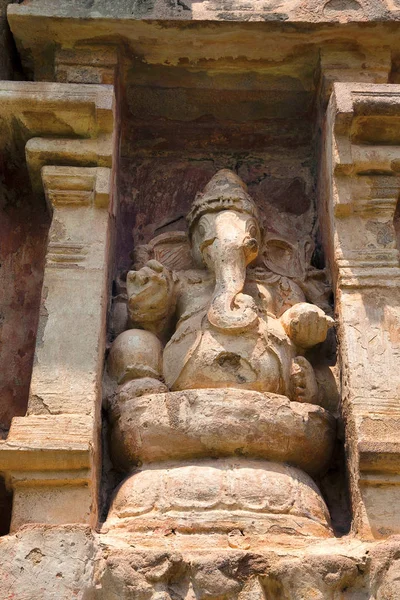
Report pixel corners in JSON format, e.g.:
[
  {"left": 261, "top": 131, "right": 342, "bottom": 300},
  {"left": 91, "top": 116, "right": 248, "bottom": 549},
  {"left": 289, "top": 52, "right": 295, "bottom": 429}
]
[{"left": 0, "top": 81, "right": 116, "bottom": 203}]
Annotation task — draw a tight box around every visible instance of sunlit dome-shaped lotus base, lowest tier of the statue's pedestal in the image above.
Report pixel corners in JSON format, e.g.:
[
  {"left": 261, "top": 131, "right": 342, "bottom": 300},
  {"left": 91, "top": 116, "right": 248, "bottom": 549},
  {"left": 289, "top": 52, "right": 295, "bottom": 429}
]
[{"left": 106, "top": 459, "right": 333, "bottom": 537}]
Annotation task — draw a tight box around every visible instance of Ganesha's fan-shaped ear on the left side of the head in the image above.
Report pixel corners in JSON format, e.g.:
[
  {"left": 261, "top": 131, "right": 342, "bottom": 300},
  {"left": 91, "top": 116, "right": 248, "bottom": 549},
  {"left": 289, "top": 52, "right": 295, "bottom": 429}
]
[{"left": 134, "top": 231, "right": 196, "bottom": 271}]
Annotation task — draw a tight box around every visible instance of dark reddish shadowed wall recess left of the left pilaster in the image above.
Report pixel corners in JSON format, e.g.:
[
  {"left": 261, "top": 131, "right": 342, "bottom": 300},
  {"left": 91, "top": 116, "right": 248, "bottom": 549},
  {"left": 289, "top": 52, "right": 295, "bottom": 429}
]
[{"left": 0, "top": 159, "right": 50, "bottom": 431}]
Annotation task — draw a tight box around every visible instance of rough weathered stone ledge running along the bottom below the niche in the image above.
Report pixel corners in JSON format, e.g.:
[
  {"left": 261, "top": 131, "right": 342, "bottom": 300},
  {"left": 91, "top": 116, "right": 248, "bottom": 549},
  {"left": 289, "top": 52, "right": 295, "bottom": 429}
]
[{"left": 0, "top": 525, "right": 400, "bottom": 600}]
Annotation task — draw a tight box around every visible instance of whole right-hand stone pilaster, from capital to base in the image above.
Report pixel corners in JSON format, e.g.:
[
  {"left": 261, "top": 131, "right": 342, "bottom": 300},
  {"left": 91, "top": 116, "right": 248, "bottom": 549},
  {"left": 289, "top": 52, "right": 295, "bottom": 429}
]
[{"left": 320, "top": 83, "right": 400, "bottom": 537}]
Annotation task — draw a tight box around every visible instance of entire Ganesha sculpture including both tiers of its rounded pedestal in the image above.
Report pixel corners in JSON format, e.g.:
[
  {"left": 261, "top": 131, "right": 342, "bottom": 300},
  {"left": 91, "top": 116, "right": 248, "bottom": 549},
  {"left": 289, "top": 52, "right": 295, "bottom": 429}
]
[{"left": 106, "top": 169, "right": 336, "bottom": 537}]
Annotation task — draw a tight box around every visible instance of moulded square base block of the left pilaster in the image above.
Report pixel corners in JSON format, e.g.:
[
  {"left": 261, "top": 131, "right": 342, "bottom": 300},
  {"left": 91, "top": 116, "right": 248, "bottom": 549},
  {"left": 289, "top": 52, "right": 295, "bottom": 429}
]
[{"left": 0, "top": 412, "right": 97, "bottom": 528}]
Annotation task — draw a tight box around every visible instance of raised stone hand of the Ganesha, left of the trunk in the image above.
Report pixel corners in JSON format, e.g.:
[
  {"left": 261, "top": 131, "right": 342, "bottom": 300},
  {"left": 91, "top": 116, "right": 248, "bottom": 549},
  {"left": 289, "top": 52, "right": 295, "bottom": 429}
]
[{"left": 126, "top": 260, "right": 174, "bottom": 323}]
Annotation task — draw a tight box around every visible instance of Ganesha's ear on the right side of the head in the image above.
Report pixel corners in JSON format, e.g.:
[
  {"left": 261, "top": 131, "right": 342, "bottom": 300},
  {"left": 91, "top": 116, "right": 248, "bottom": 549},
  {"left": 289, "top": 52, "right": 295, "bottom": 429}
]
[{"left": 262, "top": 237, "right": 306, "bottom": 279}]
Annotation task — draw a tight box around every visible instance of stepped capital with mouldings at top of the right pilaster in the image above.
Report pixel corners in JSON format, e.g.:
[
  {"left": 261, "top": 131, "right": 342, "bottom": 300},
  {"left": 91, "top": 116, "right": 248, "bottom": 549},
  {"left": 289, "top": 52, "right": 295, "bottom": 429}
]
[{"left": 327, "top": 83, "right": 400, "bottom": 289}]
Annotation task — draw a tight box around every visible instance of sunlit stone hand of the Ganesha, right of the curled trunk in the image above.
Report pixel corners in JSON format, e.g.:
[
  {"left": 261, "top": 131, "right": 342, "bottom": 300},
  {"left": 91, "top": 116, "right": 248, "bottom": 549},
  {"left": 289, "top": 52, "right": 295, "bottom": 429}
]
[{"left": 281, "top": 302, "right": 335, "bottom": 349}]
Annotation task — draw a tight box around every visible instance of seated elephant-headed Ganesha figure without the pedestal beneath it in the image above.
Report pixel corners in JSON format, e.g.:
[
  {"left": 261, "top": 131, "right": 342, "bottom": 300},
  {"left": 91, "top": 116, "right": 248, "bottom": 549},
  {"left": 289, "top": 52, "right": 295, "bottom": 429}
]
[{"left": 110, "top": 170, "right": 333, "bottom": 403}]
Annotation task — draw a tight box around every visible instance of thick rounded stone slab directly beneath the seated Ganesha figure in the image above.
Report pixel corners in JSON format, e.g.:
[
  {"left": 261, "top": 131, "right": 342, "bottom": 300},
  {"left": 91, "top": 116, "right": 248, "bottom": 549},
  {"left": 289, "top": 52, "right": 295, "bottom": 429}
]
[{"left": 108, "top": 384, "right": 336, "bottom": 475}]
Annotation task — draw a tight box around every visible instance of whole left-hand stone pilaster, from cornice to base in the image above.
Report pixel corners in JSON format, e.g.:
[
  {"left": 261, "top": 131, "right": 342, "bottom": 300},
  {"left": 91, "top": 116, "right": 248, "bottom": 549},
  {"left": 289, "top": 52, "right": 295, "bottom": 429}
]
[{"left": 0, "top": 82, "right": 116, "bottom": 530}]
